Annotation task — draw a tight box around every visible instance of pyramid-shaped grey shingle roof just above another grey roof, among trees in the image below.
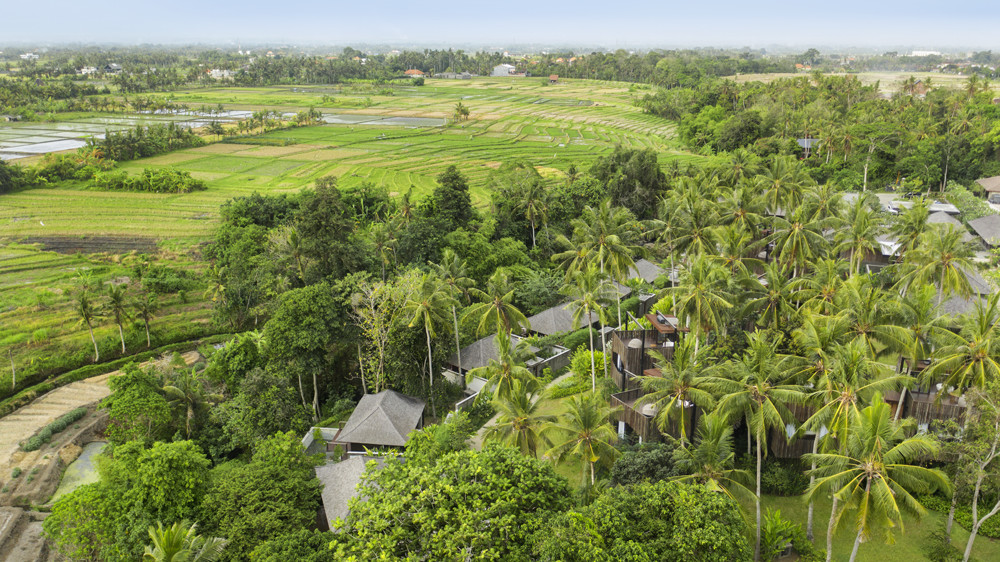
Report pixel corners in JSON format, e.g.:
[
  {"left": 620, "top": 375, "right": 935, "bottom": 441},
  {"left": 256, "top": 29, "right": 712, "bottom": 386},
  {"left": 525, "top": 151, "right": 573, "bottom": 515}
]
[{"left": 337, "top": 390, "right": 424, "bottom": 447}]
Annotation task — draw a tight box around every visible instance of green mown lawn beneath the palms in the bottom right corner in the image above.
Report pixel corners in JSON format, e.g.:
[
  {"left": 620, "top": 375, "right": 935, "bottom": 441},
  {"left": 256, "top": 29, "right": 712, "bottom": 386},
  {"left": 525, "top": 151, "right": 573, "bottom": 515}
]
[{"left": 762, "top": 496, "right": 1000, "bottom": 562}]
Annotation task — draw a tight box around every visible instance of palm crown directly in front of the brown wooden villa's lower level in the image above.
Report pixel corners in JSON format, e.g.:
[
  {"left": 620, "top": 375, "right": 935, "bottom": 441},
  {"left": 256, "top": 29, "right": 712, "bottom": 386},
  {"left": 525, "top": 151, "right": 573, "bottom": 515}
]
[{"left": 635, "top": 337, "right": 716, "bottom": 447}]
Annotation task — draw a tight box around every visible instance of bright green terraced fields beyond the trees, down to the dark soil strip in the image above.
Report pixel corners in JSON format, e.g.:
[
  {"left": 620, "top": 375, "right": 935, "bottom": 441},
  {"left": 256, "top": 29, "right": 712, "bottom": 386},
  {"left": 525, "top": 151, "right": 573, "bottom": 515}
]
[{"left": 0, "top": 79, "right": 701, "bottom": 247}]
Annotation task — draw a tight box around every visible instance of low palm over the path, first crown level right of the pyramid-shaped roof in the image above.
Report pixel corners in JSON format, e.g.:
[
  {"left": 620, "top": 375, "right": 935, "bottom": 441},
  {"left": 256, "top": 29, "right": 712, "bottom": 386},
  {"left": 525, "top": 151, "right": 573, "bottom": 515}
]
[{"left": 485, "top": 382, "right": 556, "bottom": 457}]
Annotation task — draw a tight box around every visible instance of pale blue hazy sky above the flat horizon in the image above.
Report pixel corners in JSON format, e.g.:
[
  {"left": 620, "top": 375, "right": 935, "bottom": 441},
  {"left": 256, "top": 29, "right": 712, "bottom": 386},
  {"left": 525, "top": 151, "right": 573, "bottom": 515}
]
[{"left": 7, "top": 0, "right": 1000, "bottom": 51}]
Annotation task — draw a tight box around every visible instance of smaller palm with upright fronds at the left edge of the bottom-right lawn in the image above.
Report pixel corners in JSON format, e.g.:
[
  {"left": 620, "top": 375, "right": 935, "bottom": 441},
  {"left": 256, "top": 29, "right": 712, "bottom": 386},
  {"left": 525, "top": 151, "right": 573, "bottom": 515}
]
[{"left": 674, "top": 413, "right": 754, "bottom": 505}]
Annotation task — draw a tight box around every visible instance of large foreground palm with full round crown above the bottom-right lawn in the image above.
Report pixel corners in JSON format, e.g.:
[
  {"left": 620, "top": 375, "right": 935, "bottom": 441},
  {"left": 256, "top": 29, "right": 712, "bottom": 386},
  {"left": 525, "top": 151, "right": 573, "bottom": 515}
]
[{"left": 806, "top": 394, "right": 951, "bottom": 562}]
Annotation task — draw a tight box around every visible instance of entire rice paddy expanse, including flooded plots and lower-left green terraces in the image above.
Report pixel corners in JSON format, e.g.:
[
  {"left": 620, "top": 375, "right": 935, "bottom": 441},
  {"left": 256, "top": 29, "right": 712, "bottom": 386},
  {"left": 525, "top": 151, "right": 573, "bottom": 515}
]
[{"left": 0, "top": 78, "right": 702, "bottom": 374}]
